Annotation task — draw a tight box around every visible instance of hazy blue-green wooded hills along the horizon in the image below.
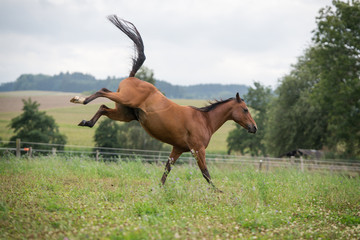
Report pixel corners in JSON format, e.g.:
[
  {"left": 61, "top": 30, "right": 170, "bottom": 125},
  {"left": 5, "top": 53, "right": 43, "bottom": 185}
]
[{"left": 0, "top": 72, "right": 248, "bottom": 99}]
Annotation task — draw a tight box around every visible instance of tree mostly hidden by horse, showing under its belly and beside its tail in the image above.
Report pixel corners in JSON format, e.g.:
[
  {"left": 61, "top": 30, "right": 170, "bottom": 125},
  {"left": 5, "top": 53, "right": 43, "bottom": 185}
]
[{"left": 94, "top": 67, "right": 170, "bottom": 150}]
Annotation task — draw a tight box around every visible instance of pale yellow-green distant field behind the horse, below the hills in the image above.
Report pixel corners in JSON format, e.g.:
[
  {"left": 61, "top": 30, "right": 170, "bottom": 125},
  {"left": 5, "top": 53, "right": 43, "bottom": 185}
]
[{"left": 0, "top": 91, "right": 235, "bottom": 152}]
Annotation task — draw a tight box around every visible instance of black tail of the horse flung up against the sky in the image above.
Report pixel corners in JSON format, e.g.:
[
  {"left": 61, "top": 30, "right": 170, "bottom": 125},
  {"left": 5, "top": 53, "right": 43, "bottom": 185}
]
[{"left": 108, "top": 15, "right": 146, "bottom": 77}]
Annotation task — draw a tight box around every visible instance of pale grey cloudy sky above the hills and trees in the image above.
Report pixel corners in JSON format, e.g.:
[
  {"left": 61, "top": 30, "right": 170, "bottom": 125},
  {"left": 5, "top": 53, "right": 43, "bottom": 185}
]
[{"left": 0, "top": 0, "right": 331, "bottom": 87}]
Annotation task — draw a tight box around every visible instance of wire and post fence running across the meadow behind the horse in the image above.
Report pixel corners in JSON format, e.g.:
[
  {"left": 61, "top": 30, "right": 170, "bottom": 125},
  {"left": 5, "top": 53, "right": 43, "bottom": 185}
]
[{"left": 0, "top": 139, "right": 360, "bottom": 174}]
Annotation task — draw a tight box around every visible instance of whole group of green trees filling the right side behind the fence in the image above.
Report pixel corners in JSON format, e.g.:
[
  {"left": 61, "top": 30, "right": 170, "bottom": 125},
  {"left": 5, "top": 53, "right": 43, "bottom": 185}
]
[{"left": 227, "top": 1, "right": 360, "bottom": 158}]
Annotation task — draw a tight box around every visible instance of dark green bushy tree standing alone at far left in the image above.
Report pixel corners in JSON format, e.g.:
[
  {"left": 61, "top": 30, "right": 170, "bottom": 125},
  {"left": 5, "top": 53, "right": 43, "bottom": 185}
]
[{"left": 9, "top": 98, "right": 66, "bottom": 149}]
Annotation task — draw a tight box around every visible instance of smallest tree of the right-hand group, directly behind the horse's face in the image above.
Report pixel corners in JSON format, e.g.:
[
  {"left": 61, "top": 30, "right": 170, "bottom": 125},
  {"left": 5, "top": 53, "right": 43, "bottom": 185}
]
[{"left": 226, "top": 82, "right": 272, "bottom": 156}]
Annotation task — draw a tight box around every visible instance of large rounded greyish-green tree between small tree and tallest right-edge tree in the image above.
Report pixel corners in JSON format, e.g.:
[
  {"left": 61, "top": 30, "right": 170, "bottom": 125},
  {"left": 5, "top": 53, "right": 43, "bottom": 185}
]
[{"left": 265, "top": 48, "right": 327, "bottom": 157}]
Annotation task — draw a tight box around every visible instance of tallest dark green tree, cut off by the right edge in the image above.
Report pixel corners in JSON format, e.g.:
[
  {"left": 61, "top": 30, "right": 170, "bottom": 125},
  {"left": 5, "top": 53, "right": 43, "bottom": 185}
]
[{"left": 311, "top": 0, "right": 360, "bottom": 157}]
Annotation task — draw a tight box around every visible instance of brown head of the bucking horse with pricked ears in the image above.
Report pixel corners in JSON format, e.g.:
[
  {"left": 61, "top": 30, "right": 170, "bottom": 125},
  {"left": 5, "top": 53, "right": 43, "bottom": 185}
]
[{"left": 232, "top": 93, "right": 257, "bottom": 133}]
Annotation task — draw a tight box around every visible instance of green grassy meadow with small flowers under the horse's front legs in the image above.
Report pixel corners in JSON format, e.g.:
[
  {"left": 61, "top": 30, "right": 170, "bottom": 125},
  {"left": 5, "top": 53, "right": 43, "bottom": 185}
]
[{"left": 0, "top": 156, "right": 360, "bottom": 239}]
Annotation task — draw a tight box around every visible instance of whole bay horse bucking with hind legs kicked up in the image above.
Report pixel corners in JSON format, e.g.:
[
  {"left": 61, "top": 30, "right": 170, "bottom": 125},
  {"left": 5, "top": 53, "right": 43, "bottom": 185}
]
[{"left": 70, "top": 15, "right": 257, "bottom": 189}]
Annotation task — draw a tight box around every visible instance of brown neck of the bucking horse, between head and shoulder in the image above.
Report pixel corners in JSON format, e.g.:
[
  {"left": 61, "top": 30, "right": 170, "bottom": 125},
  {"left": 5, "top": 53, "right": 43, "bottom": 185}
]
[{"left": 208, "top": 103, "right": 232, "bottom": 133}]
